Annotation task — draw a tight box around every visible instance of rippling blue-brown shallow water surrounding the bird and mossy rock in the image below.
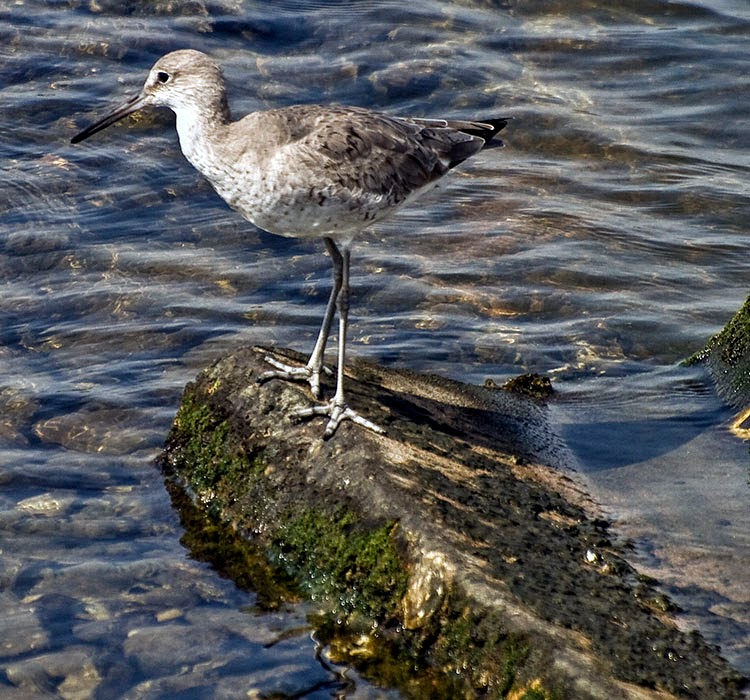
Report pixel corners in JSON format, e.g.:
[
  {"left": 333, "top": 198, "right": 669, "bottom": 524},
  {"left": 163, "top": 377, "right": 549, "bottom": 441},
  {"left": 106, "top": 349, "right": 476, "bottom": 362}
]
[{"left": 0, "top": 0, "right": 750, "bottom": 698}]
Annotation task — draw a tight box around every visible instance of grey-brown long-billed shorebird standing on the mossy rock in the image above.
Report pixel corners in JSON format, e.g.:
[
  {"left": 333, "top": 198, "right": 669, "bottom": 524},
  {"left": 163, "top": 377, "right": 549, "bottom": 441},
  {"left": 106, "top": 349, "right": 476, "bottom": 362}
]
[{"left": 71, "top": 50, "right": 507, "bottom": 438}]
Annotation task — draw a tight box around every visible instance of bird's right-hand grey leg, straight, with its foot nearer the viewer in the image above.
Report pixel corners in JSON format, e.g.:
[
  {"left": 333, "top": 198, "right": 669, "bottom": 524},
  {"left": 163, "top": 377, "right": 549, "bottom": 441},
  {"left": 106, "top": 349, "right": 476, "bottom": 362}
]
[{"left": 294, "top": 239, "right": 385, "bottom": 439}]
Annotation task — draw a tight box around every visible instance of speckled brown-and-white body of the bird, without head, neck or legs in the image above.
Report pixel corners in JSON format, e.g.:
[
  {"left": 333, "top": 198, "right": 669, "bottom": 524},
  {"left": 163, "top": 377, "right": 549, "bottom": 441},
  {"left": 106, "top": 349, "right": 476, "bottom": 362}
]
[{"left": 212, "top": 105, "right": 484, "bottom": 240}]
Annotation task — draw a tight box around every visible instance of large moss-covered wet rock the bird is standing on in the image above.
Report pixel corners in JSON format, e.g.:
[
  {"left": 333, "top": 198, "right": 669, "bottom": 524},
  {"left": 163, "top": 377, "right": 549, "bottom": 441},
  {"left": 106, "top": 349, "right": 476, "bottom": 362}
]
[{"left": 161, "top": 349, "right": 744, "bottom": 699}]
